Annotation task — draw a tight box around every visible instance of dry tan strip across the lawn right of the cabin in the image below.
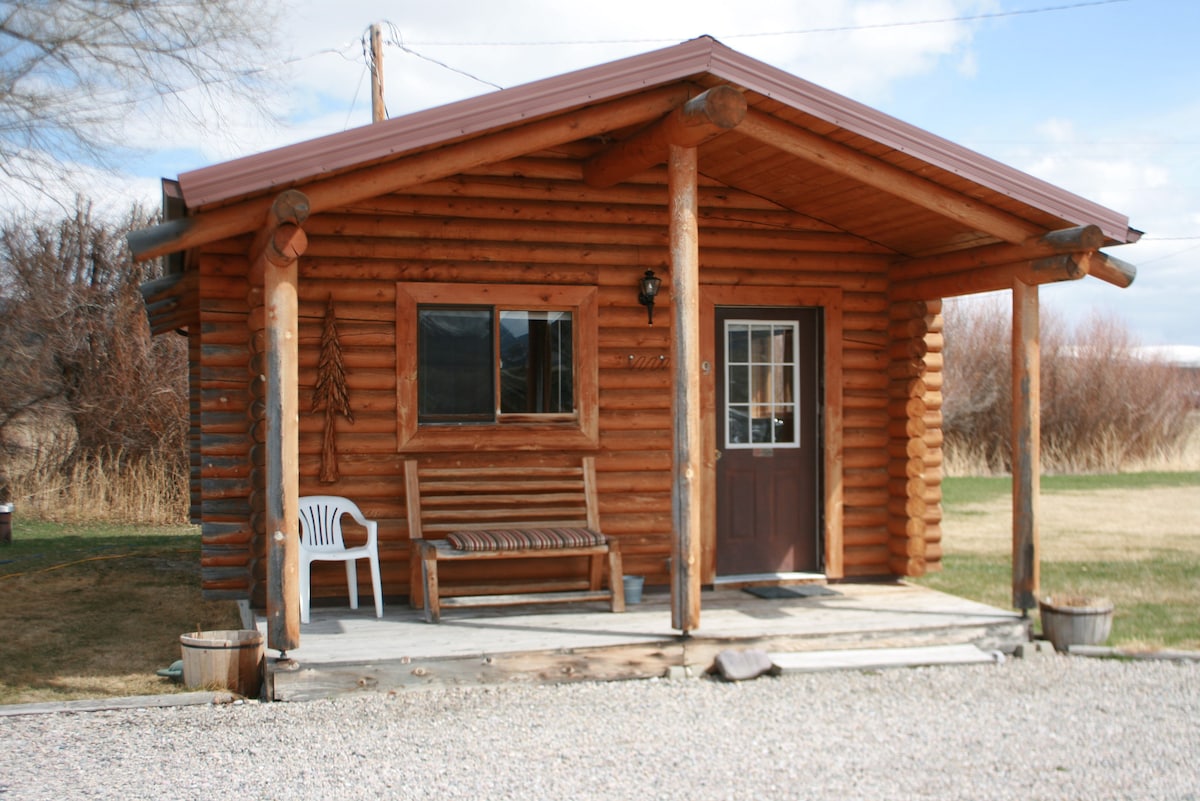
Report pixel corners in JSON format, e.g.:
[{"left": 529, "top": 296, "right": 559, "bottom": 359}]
[{"left": 942, "top": 487, "right": 1200, "bottom": 561}]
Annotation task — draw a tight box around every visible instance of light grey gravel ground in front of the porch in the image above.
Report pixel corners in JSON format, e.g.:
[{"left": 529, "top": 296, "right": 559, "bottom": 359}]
[{"left": 0, "top": 656, "right": 1200, "bottom": 801}]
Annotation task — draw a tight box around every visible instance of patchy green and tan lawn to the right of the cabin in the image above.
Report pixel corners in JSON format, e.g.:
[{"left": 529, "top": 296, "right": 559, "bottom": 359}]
[{"left": 917, "top": 472, "right": 1200, "bottom": 650}]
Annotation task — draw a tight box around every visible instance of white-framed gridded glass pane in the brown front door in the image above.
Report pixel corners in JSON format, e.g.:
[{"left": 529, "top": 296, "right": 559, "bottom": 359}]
[{"left": 725, "top": 320, "right": 799, "bottom": 447}]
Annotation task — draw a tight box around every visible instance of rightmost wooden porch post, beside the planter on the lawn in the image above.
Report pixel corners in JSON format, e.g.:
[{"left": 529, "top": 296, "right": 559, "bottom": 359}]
[{"left": 1013, "top": 281, "right": 1042, "bottom": 610}]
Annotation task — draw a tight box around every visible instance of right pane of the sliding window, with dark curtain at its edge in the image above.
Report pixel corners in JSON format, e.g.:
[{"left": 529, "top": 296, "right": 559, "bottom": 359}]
[{"left": 500, "top": 311, "right": 575, "bottom": 414}]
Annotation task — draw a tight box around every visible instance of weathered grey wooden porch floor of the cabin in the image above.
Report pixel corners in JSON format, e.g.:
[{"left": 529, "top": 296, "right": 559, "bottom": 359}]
[{"left": 267, "top": 583, "right": 1030, "bottom": 700}]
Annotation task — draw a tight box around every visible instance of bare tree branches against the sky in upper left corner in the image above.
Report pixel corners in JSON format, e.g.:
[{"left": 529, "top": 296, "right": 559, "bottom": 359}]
[{"left": 0, "top": 0, "right": 278, "bottom": 194}]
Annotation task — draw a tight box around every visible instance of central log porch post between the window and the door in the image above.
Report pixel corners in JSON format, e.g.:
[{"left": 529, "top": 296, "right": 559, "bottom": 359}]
[{"left": 667, "top": 145, "right": 702, "bottom": 633}]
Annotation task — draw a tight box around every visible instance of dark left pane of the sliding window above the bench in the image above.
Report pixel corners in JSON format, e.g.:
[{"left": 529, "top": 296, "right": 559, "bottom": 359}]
[{"left": 416, "top": 308, "right": 496, "bottom": 422}]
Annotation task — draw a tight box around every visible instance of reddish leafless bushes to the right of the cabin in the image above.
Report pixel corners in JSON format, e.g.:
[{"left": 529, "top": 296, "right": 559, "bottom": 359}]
[{"left": 942, "top": 297, "right": 1195, "bottom": 475}]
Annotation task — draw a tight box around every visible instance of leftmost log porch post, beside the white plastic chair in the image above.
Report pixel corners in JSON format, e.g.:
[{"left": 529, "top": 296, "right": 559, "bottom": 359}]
[{"left": 251, "top": 191, "right": 308, "bottom": 656}]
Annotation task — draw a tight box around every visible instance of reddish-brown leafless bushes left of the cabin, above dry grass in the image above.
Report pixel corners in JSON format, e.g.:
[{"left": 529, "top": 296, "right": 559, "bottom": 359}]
[{"left": 0, "top": 200, "right": 187, "bottom": 495}]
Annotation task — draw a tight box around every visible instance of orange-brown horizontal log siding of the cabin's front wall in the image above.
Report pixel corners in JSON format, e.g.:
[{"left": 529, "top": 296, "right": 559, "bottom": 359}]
[{"left": 205, "top": 157, "right": 894, "bottom": 598}]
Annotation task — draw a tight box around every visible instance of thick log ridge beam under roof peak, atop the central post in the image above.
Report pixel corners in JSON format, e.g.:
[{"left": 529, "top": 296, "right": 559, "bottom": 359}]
[{"left": 583, "top": 85, "right": 746, "bottom": 188}]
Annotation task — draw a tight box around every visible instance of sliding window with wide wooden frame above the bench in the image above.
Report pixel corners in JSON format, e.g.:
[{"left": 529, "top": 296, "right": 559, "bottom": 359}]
[{"left": 396, "top": 283, "right": 599, "bottom": 451}]
